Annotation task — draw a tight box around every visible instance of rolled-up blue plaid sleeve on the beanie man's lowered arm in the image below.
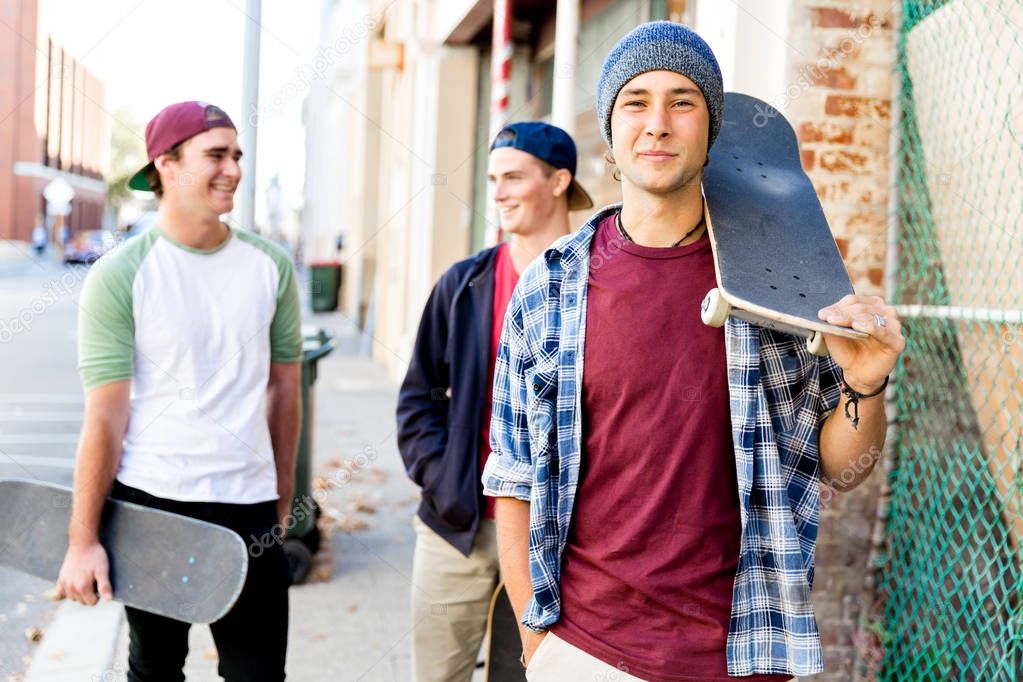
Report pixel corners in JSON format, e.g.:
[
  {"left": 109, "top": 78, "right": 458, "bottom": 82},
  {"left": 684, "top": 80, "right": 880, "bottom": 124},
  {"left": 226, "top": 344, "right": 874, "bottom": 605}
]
[{"left": 483, "top": 287, "right": 533, "bottom": 502}]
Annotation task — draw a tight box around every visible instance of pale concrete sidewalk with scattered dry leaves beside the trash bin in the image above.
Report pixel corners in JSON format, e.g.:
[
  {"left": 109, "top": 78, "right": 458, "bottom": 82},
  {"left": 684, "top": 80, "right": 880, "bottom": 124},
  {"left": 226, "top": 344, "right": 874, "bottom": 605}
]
[{"left": 26, "top": 314, "right": 431, "bottom": 682}]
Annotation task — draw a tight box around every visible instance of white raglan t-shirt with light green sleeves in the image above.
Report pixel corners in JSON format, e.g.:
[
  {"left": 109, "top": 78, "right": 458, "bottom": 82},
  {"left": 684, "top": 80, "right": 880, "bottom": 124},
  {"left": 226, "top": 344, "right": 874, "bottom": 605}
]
[{"left": 78, "top": 227, "right": 302, "bottom": 504}]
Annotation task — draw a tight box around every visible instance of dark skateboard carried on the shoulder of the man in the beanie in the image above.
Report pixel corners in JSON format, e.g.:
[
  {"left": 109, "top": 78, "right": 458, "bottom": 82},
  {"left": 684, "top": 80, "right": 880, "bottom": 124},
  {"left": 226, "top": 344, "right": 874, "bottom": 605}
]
[{"left": 702, "top": 92, "right": 868, "bottom": 356}]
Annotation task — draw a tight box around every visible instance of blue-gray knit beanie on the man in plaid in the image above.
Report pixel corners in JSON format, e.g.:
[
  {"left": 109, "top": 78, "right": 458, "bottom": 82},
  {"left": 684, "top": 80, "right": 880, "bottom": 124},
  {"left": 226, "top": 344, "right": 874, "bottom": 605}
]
[{"left": 596, "top": 21, "right": 724, "bottom": 148}]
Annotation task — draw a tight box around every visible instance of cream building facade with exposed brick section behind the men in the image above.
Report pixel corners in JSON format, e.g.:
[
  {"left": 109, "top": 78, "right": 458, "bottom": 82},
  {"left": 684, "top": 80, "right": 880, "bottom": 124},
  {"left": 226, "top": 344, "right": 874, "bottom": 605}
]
[{"left": 303, "top": 0, "right": 895, "bottom": 681}]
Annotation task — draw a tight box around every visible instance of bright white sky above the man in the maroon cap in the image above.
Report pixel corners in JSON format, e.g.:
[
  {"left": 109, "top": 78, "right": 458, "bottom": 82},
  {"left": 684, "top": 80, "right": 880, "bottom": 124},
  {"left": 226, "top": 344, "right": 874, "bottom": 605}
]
[{"left": 39, "top": 0, "right": 321, "bottom": 223}]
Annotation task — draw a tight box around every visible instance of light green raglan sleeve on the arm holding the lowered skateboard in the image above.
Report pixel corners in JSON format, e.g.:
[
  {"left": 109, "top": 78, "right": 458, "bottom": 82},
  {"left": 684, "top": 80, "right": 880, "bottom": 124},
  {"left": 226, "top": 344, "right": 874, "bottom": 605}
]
[{"left": 78, "top": 254, "right": 135, "bottom": 393}]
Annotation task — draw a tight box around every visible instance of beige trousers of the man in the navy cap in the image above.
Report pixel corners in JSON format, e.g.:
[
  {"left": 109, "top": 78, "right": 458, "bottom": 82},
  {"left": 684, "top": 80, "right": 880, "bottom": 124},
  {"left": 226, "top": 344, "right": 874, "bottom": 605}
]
[{"left": 412, "top": 516, "right": 499, "bottom": 682}]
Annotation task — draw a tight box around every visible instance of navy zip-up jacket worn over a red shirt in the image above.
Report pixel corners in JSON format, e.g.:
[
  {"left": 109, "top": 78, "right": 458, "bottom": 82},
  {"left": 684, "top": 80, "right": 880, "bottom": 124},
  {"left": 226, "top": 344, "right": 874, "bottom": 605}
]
[{"left": 397, "top": 246, "right": 497, "bottom": 556}]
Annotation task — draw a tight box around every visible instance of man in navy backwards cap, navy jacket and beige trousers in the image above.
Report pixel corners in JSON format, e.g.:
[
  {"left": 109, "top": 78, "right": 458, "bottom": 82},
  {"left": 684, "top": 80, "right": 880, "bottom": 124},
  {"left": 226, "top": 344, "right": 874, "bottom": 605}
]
[{"left": 397, "top": 122, "right": 593, "bottom": 682}]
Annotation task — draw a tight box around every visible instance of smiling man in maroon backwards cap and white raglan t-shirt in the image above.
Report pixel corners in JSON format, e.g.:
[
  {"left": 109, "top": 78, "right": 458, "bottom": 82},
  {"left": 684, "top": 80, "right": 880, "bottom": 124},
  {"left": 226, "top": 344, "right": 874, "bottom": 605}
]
[{"left": 57, "top": 101, "right": 302, "bottom": 682}]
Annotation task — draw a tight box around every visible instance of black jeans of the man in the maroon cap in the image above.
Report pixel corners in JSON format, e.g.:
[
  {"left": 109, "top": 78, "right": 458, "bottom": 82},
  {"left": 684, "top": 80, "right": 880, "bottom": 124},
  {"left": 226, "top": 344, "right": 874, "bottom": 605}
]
[{"left": 110, "top": 482, "right": 291, "bottom": 682}]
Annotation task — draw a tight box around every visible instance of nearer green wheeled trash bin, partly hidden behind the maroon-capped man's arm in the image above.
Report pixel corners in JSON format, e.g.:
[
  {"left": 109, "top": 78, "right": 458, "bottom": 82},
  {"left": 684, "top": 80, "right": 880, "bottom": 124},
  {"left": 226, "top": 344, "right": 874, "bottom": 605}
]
[{"left": 284, "top": 326, "right": 335, "bottom": 584}]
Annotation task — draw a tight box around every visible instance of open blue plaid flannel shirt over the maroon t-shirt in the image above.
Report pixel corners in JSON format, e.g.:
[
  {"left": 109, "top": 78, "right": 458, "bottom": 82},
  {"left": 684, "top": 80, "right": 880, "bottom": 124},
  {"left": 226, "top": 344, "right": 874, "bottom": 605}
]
[{"left": 483, "top": 204, "right": 842, "bottom": 676}]
